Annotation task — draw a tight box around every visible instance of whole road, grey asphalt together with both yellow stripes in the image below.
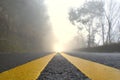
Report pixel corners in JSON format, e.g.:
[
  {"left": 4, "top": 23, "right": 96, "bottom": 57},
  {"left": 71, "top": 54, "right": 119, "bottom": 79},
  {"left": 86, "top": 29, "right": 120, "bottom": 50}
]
[{"left": 0, "top": 51, "right": 120, "bottom": 80}]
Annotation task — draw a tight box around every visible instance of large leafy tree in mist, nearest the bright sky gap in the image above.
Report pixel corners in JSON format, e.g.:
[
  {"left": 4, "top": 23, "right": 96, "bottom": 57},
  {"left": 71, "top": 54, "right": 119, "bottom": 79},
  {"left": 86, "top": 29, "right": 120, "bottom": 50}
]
[{"left": 69, "top": 1, "right": 104, "bottom": 47}]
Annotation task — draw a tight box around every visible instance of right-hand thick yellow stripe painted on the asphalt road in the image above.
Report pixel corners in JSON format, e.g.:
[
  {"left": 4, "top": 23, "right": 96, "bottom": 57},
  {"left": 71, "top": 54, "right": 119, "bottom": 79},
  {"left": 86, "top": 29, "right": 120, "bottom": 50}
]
[{"left": 61, "top": 53, "right": 120, "bottom": 80}]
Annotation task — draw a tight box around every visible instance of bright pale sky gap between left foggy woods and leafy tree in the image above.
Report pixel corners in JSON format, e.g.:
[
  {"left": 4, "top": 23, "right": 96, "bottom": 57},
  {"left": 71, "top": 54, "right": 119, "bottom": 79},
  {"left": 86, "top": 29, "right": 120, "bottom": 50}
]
[{"left": 45, "top": 0, "right": 84, "bottom": 51}]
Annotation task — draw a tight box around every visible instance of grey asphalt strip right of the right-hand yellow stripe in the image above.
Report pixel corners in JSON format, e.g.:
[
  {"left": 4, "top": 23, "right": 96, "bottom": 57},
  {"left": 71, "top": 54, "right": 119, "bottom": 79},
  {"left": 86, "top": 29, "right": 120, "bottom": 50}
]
[{"left": 68, "top": 51, "right": 120, "bottom": 69}]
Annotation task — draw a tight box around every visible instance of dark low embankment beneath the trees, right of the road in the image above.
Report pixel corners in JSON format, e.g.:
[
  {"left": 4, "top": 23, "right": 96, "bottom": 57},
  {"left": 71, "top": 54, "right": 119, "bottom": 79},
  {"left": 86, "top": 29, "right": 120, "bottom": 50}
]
[{"left": 78, "top": 43, "right": 120, "bottom": 52}]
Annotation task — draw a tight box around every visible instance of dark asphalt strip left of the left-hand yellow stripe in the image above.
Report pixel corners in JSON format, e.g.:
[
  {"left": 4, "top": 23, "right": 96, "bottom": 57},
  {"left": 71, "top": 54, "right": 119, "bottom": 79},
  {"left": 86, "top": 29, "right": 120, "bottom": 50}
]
[{"left": 0, "top": 52, "right": 50, "bottom": 72}]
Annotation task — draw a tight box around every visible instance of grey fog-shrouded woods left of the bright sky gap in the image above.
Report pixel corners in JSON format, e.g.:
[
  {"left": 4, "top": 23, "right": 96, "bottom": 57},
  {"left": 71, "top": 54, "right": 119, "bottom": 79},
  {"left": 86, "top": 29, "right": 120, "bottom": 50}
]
[{"left": 0, "top": 0, "right": 54, "bottom": 52}]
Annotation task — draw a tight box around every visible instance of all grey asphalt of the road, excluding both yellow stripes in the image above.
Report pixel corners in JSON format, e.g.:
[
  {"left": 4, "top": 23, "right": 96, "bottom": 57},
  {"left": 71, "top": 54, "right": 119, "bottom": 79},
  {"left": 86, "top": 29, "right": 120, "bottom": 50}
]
[{"left": 0, "top": 51, "right": 120, "bottom": 80}]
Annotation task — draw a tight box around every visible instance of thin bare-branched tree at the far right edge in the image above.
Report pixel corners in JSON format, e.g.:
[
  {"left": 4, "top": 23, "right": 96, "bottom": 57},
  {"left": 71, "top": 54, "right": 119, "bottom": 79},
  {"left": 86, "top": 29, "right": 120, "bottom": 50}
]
[{"left": 104, "top": 0, "right": 120, "bottom": 44}]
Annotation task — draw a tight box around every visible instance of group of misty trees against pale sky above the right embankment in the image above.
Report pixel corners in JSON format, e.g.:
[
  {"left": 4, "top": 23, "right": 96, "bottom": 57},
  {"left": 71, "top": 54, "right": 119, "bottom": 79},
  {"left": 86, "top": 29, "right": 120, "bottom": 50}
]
[{"left": 68, "top": 0, "right": 120, "bottom": 48}]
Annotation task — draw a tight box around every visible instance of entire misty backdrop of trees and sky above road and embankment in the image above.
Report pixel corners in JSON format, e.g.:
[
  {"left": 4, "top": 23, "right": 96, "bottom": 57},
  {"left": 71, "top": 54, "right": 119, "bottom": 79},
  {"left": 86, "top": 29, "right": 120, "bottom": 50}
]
[{"left": 0, "top": 0, "right": 120, "bottom": 53}]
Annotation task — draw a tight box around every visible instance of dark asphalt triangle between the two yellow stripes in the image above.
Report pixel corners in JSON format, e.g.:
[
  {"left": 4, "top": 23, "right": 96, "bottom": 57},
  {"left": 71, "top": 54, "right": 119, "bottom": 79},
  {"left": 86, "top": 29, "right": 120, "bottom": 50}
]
[{"left": 38, "top": 54, "right": 90, "bottom": 80}]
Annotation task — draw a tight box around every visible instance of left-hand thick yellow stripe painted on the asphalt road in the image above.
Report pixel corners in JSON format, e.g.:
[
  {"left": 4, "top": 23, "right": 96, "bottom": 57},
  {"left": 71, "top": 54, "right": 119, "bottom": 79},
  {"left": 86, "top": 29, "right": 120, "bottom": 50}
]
[{"left": 0, "top": 53, "right": 55, "bottom": 80}]
